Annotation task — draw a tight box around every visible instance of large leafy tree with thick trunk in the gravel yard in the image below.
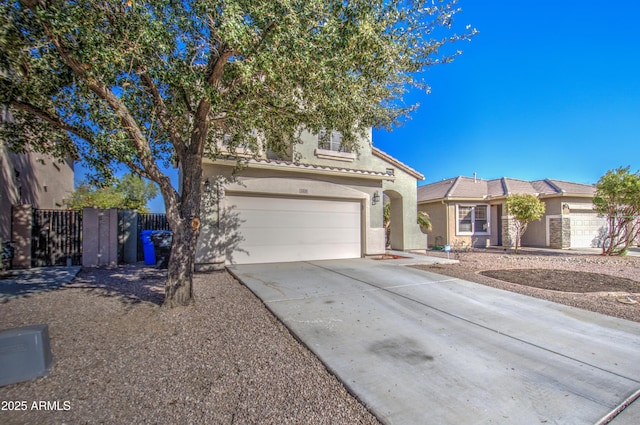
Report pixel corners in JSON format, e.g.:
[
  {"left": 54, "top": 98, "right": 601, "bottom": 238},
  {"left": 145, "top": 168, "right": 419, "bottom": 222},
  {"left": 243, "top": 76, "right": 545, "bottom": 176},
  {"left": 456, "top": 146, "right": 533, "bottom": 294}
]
[{"left": 0, "top": 0, "right": 475, "bottom": 306}]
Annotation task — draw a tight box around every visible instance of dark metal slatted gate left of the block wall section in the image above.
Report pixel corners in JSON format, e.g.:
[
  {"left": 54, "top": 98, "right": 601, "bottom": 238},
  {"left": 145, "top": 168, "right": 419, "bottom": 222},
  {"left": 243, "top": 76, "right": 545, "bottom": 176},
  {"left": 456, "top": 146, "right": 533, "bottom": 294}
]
[{"left": 31, "top": 210, "right": 82, "bottom": 267}]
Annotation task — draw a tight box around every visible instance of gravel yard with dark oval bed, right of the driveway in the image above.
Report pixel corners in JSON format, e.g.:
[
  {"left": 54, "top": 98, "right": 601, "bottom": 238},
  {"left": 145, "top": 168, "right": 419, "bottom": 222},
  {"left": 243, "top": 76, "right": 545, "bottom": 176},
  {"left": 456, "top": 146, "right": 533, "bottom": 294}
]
[{"left": 414, "top": 248, "right": 640, "bottom": 322}]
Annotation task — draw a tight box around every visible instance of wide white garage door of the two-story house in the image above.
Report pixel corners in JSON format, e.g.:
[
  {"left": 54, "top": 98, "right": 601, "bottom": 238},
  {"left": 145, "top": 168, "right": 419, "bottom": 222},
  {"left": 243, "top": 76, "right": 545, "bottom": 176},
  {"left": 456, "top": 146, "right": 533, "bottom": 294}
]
[{"left": 227, "top": 196, "right": 362, "bottom": 264}]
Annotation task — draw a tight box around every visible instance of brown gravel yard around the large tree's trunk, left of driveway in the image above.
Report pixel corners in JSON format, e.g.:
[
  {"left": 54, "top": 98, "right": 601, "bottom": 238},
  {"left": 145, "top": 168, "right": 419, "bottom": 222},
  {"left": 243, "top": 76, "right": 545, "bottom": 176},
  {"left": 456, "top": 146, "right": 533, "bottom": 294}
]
[{"left": 0, "top": 265, "right": 378, "bottom": 425}]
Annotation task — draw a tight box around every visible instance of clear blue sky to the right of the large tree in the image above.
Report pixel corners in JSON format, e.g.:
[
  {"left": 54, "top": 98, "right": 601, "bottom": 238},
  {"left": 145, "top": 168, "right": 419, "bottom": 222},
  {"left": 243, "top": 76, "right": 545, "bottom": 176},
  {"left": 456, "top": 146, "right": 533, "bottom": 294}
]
[{"left": 373, "top": 0, "right": 640, "bottom": 184}]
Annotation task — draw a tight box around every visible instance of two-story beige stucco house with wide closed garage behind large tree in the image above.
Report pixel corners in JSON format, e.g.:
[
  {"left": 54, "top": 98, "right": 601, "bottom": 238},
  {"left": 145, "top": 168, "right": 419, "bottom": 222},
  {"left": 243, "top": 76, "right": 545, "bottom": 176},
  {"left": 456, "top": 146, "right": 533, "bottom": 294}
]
[{"left": 196, "top": 126, "right": 426, "bottom": 270}]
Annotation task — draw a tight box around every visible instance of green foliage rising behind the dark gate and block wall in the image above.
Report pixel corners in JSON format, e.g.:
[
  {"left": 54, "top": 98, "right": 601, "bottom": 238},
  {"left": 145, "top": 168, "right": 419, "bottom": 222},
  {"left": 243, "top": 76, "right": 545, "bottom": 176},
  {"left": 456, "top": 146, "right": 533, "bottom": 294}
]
[{"left": 66, "top": 174, "right": 158, "bottom": 213}]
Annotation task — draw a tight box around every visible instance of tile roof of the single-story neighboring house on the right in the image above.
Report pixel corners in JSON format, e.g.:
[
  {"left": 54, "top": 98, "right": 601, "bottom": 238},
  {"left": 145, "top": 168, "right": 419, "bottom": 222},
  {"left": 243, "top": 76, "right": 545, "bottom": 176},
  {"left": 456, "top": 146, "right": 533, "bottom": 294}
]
[{"left": 418, "top": 176, "right": 595, "bottom": 202}]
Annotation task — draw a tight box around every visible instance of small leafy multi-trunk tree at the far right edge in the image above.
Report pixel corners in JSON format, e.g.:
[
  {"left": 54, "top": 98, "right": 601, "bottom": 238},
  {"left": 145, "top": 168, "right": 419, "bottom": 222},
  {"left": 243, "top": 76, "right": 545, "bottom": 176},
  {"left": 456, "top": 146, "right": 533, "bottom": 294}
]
[{"left": 593, "top": 167, "right": 640, "bottom": 255}]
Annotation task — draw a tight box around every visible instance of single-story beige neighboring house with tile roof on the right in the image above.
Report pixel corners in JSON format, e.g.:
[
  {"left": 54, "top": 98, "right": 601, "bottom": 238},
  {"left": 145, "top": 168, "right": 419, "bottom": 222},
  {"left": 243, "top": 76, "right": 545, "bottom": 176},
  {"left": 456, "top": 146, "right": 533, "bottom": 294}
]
[{"left": 418, "top": 176, "right": 606, "bottom": 248}]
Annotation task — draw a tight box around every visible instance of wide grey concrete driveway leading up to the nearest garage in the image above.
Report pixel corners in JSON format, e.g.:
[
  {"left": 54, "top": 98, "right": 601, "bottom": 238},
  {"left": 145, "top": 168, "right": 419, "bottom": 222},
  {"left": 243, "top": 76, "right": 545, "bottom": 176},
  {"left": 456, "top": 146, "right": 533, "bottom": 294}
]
[{"left": 230, "top": 259, "right": 640, "bottom": 425}]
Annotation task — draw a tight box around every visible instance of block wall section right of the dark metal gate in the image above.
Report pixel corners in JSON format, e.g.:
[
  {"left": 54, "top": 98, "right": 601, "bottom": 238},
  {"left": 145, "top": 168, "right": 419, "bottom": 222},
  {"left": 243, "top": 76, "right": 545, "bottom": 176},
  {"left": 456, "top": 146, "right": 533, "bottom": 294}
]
[{"left": 82, "top": 208, "right": 118, "bottom": 267}]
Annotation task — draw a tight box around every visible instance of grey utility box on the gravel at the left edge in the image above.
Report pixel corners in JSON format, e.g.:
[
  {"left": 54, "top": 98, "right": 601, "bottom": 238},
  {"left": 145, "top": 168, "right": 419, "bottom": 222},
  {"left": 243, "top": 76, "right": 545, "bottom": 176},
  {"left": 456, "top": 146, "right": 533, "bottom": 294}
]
[{"left": 0, "top": 324, "right": 53, "bottom": 387}]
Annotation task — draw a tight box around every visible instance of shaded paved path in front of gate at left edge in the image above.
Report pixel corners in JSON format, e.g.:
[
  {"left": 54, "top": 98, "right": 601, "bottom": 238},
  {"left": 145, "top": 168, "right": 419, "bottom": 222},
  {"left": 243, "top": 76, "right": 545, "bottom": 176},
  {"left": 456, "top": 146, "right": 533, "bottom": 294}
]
[{"left": 0, "top": 266, "right": 81, "bottom": 302}]
